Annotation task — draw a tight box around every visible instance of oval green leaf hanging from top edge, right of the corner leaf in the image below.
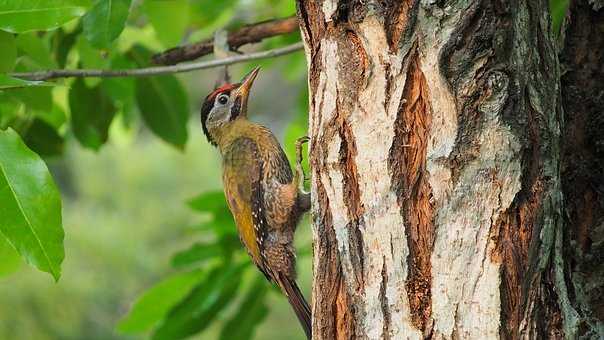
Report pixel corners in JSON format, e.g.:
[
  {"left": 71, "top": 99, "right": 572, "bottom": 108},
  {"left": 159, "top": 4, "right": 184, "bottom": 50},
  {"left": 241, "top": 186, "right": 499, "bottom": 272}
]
[{"left": 84, "top": 0, "right": 131, "bottom": 48}]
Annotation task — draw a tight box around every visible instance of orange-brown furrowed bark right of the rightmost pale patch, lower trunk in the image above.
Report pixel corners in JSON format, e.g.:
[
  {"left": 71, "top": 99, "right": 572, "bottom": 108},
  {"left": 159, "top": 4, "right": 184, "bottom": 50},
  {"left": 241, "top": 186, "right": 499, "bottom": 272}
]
[{"left": 493, "top": 91, "right": 563, "bottom": 339}]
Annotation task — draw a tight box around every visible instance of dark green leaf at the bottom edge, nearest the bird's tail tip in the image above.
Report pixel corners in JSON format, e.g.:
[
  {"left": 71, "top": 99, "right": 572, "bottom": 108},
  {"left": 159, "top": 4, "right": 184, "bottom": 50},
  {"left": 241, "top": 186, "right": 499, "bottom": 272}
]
[{"left": 220, "top": 276, "right": 268, "bottom": 340}]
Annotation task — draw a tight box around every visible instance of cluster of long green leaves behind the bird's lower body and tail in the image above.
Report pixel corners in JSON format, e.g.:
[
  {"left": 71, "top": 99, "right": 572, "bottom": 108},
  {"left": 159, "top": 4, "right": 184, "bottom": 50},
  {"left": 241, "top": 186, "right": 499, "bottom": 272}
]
[{"left": 118, "top": 191, "right": 270, "bottom": 340}]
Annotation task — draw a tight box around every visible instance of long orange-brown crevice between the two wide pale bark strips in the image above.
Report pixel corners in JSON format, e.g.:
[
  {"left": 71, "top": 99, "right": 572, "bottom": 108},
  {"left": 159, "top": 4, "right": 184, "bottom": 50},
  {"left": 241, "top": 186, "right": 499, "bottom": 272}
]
[{"left": 388, "top": 52, "right": 434, "bottom": 331}]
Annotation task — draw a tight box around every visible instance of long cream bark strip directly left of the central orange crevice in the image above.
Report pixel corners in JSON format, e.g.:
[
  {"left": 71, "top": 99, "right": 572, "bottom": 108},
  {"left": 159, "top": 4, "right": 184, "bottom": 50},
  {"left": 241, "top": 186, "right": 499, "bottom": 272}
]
[{"left": 350, "top": 17, "right": 421, "bottom": 339}]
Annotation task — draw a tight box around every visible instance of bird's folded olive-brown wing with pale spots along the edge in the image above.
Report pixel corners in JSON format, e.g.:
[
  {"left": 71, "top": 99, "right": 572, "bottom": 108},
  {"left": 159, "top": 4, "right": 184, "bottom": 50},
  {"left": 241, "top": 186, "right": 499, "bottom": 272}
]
[{"left": 223, "top": 137, "right": 267, "bottom": 269}]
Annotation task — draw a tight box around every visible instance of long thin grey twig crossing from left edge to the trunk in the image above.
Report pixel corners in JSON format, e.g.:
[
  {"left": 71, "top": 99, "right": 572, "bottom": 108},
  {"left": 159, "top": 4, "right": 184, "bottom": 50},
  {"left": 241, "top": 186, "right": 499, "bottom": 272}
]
[{"left": 11, "top": 42, "right": 303, "bottom": 80}]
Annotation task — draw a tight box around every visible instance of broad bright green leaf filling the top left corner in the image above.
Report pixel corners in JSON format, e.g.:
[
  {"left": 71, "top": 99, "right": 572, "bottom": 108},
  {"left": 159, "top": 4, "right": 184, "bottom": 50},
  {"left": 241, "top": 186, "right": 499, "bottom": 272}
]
[{"left": 0, "top": 0, "right": 89, "bottom": 33}]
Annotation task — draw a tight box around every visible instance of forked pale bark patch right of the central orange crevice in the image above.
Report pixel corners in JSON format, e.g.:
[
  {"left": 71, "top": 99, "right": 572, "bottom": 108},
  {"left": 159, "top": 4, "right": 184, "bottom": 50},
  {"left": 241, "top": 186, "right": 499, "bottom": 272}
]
[{"left": 421, "top": 7, "right": 522, "bottom": 339}]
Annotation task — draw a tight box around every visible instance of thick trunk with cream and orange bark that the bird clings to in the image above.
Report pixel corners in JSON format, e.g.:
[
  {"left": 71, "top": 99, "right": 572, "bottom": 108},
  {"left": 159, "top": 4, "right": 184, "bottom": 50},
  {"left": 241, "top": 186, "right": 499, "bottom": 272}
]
[{"left": 298, "top": 0, "right": 600, "bottom": 339}]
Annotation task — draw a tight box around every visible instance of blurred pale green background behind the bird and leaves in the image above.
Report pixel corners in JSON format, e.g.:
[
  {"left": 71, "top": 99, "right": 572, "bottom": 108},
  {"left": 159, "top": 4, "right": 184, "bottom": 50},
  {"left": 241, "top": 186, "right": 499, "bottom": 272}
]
[{"left": 0, "top": 65, "right": 311, "bottom": 339}]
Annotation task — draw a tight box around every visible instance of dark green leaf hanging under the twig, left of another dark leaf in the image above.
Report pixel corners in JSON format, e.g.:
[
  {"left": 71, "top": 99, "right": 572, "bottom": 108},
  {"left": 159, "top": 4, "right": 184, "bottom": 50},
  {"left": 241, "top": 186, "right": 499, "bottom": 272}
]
[{"left": 69, "top": 79, "right": 116, "bottom": 150}]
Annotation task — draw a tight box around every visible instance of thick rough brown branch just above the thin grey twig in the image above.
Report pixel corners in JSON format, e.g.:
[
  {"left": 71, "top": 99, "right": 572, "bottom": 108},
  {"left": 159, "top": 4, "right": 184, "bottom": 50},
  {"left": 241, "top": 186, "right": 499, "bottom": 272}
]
[{"left": 152, "top": 17, "right": 298, "bottom": 65}]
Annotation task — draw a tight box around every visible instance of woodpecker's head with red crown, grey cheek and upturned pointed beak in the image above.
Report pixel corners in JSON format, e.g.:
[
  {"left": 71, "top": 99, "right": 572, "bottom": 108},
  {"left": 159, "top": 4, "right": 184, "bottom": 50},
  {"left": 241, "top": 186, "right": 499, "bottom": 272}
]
[{"left": 201, "top": 67, "right": 260, "bottom": 145}]
